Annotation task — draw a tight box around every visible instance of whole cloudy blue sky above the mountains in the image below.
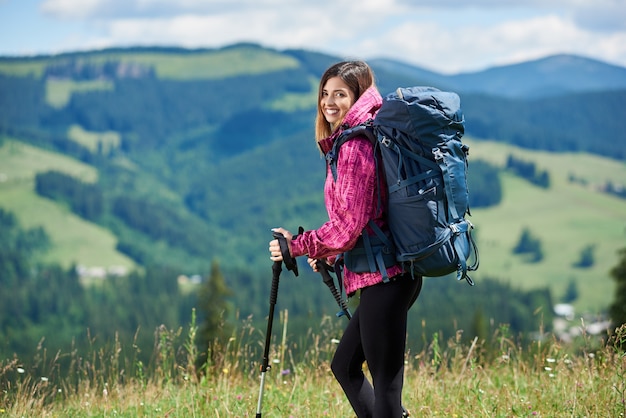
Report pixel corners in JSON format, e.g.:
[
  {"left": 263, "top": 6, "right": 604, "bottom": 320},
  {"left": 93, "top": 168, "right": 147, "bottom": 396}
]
[{"left": 0, "top": 0, "right": 626, "bottom": 74}]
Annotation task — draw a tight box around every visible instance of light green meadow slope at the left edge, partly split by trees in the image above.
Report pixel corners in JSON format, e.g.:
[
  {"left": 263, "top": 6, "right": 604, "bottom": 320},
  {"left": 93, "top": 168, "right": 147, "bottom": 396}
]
[{"left": 0, "top": 140, "right": 134, "bottom": 268}]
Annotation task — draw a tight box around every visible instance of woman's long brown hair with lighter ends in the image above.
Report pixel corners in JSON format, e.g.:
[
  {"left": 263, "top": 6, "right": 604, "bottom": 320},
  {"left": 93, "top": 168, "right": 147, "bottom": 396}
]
[{"left": 315, "top": 61, "right": 374, "bottom": 141}]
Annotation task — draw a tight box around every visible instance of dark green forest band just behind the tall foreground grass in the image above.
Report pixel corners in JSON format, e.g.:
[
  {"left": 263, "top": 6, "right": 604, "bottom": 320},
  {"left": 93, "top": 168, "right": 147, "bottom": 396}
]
[{"left": 0, "top": 202, "right": 626, "bottom": 370}]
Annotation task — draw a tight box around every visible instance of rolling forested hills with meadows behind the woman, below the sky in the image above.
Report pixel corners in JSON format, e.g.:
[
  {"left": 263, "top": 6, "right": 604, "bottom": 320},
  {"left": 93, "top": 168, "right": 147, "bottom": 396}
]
[{"left": 0, "top": 44, "right": 626, "bottom": 362}]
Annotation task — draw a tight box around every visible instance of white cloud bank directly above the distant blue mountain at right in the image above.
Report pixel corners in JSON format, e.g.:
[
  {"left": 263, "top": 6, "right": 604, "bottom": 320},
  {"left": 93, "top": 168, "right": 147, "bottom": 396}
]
[{"left": 316, "top": 15, "right": 626, "bottom": 73}]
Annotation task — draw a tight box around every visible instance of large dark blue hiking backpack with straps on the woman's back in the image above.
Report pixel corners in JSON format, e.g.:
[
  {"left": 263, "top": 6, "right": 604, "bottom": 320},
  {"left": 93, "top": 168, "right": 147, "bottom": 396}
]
[{"left": 326, "top": 87, "right": 478, "bottom": 285}]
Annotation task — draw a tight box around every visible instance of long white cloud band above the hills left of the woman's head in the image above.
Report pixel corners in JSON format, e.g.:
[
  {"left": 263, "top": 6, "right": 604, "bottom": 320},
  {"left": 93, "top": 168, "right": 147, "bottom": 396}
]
[{"left": 93, "top": 0, "right": 402, "bottom": 50}]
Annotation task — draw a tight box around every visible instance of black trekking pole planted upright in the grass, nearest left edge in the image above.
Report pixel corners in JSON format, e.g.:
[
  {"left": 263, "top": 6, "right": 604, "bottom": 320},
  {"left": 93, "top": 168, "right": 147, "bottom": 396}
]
[{"left": 256, "top": 232, "right": 298, "bottom": 418}]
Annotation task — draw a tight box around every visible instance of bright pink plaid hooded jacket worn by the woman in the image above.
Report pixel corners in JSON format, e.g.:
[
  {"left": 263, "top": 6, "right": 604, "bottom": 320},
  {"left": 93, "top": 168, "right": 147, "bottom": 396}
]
[{"left": 291, "top": 87, "right": 402, "bottom": 295}]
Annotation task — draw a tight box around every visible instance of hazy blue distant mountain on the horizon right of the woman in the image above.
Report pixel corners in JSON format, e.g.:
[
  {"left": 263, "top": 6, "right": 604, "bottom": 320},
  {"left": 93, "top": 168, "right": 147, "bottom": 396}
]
[{"left": 370, "top": 54, "right": 626, "bottom": 99}]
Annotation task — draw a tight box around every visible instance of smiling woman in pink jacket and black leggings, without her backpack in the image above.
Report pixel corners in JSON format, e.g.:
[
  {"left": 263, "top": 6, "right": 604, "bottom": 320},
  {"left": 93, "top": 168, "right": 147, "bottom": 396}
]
[{"left": 269, "top": 61, "right": 422, "bottom": 418}]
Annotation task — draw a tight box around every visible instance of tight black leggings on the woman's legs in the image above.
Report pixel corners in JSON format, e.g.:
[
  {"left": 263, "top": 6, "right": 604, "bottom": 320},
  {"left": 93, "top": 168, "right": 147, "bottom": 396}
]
[{"left": 331, "top": 274, "right": 422, "bottom": 418}]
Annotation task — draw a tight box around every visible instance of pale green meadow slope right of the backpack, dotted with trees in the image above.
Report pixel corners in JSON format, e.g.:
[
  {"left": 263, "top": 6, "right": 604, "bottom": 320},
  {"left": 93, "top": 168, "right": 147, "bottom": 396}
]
[{"left": 468, "top": 140, "right": 626, "bottom": 311}]
